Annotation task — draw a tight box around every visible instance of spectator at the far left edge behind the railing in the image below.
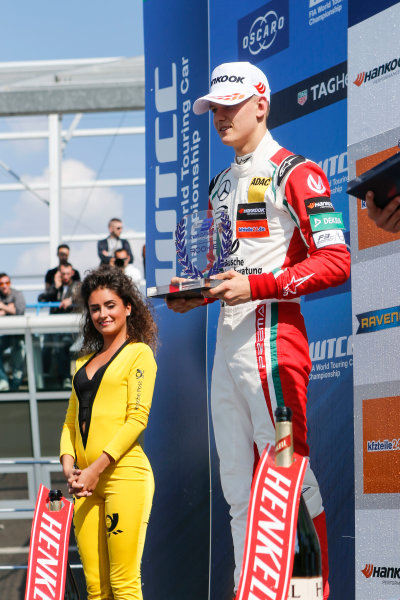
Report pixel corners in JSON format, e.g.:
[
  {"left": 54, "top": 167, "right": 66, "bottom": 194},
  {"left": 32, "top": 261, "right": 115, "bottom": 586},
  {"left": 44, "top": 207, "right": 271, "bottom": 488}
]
[{"left": 0, "top": 273, "right": 25, "bottom": 392}]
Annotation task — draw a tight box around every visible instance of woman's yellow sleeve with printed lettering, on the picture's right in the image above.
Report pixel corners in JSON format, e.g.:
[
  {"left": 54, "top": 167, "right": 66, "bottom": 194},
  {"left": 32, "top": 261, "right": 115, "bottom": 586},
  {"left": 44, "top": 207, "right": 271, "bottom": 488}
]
[{"left": 103, "top": 344, "right": 157, "bottom": 461}]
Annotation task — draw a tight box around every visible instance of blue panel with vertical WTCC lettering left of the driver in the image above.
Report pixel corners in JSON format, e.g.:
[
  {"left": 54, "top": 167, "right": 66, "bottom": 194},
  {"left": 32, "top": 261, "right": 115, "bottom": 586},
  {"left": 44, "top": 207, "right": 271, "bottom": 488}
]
[{"left": 142, "top": 0, "right": 212, "bottom": 600}]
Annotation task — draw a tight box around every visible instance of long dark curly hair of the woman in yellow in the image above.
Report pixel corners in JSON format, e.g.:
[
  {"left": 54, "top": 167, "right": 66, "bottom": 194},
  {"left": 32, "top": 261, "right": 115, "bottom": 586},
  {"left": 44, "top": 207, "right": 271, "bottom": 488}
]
[{"left": 80, "top": 266, "right": 157, "bottom": 354}]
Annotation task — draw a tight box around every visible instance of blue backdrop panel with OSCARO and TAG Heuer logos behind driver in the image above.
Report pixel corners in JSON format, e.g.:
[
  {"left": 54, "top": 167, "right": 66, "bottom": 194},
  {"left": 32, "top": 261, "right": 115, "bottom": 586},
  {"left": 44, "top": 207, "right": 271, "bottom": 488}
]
[{"left": 210, "top": 0, "right": 354, "bottom": 600}]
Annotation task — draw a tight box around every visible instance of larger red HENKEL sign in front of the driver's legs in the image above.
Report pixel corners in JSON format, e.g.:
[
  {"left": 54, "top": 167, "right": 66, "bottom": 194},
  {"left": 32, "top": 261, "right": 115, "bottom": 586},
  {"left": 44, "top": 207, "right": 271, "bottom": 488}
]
[{"left": 236, "top": 439, "right": 308, "bottom": 600}]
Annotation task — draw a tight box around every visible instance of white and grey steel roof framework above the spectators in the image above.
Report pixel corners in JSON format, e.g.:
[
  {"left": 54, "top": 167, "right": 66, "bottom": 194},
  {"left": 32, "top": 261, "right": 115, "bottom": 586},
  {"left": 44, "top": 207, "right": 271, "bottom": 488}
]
[{"left": 0, "top": 56, "right": 145, "bottom": 289}]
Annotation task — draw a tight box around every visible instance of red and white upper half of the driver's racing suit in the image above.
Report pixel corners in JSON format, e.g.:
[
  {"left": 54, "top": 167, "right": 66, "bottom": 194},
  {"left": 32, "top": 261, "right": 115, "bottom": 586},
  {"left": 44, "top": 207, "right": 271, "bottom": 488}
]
[{"left": 209, "top": 133, "right": 350, "bottom": 300}]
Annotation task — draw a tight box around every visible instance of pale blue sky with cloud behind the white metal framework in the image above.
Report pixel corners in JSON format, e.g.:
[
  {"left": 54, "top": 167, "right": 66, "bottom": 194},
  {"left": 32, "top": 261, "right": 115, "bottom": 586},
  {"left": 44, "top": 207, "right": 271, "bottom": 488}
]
[{"left": 0, "top": 0, "right": 145, "bottom": 287}]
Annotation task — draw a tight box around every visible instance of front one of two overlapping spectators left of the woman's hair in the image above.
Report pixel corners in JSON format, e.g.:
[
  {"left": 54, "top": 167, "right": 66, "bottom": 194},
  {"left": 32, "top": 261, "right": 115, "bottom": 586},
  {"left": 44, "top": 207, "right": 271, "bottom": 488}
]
[{"left": 38, "top": 262, "right": 80, "bottom": 390}]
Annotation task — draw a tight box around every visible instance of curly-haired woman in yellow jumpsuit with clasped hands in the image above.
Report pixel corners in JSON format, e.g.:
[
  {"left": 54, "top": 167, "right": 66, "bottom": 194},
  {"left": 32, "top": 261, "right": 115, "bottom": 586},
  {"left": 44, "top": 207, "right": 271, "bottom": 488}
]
[{"left": 60, "top": 267, "right": 157, "bottom": 600}]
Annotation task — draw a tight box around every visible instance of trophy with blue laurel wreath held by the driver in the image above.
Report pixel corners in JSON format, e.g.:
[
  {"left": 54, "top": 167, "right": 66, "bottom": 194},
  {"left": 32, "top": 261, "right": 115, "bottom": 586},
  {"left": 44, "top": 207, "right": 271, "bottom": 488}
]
[{"left": 147, "top": 210, "right": 232, "bottom": 298}]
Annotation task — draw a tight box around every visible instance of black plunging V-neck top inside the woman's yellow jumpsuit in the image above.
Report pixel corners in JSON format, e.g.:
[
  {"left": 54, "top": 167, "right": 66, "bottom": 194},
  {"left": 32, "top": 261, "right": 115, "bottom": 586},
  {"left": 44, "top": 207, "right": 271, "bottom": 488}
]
[{"left": 73, "top": 340, "right": 130, "bottom": 448}]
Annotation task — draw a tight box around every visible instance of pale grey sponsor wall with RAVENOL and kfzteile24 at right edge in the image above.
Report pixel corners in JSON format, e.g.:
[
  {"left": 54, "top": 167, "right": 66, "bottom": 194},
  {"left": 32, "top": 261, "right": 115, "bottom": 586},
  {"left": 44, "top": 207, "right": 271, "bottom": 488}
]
[{"left": 348, "top": 0, "right": 400, "bottom": 600}]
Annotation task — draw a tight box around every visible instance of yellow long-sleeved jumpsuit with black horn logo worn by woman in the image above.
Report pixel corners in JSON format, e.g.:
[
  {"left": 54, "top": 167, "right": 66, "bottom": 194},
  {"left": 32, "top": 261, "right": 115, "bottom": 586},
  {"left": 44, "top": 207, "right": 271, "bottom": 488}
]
[{"left": 60, "top": 343, "right": 157, "bottom": 600}]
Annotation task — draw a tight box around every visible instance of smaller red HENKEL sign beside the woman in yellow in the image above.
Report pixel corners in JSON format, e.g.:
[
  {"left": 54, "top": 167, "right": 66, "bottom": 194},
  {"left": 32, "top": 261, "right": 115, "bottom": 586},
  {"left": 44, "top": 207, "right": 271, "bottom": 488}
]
[{"left": 25, "top": 485, "right": 74, "bottom": 600}]
